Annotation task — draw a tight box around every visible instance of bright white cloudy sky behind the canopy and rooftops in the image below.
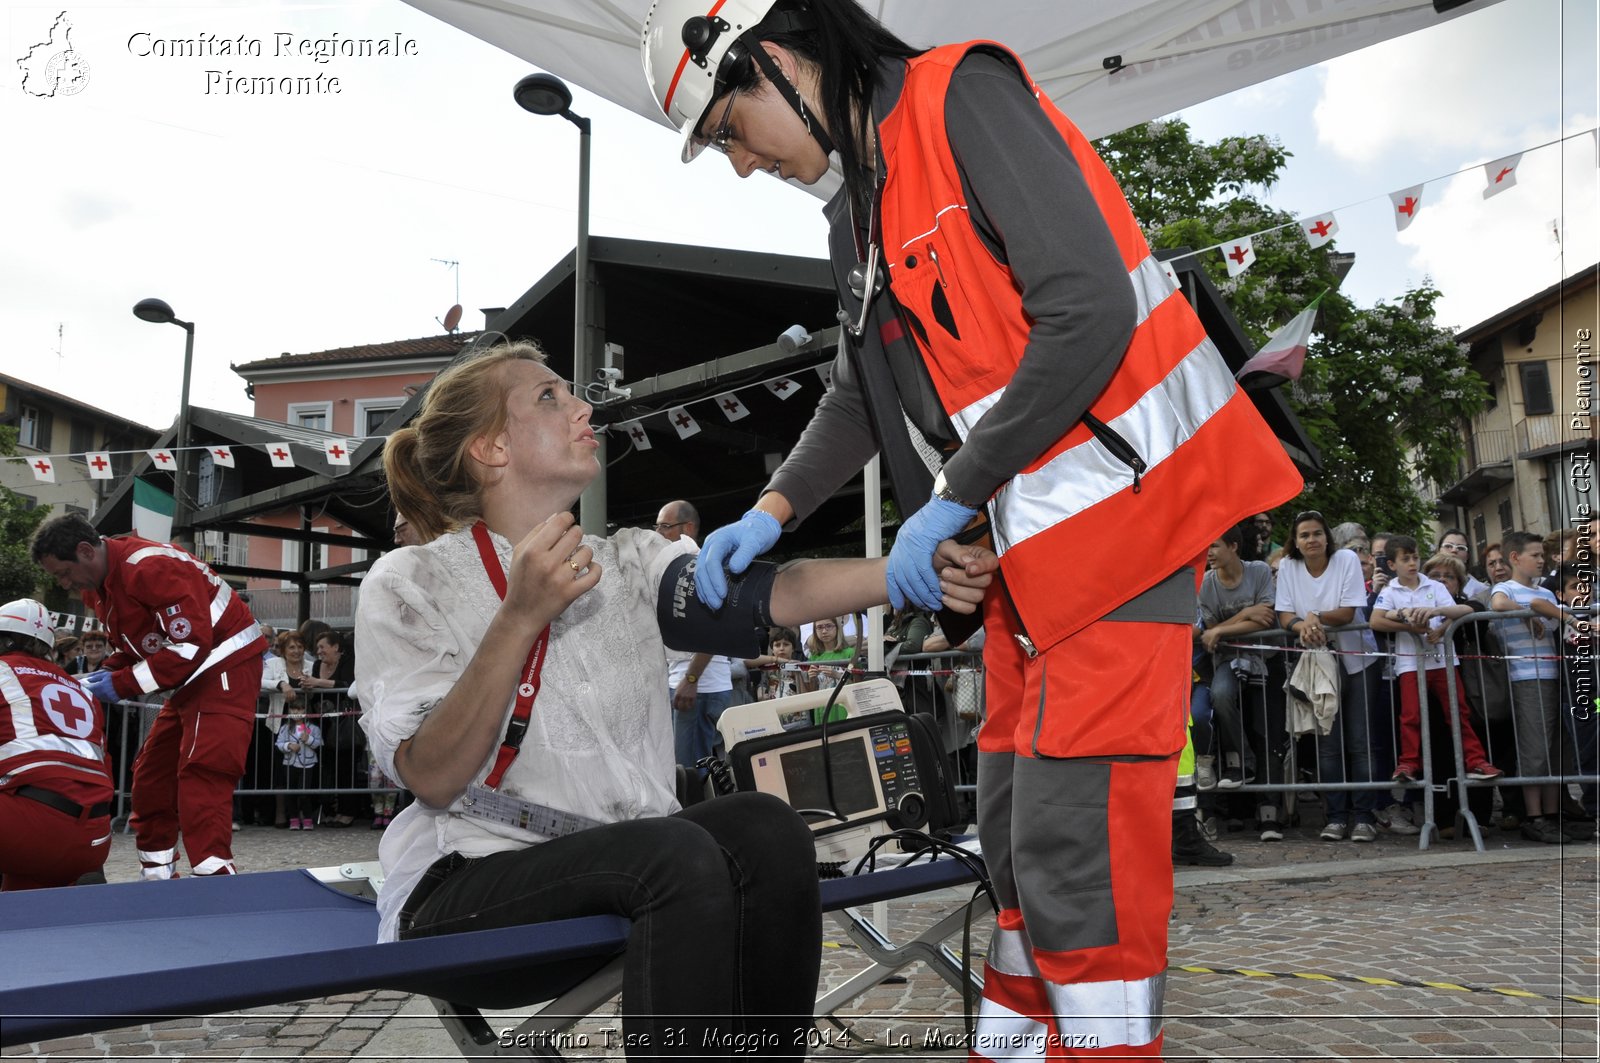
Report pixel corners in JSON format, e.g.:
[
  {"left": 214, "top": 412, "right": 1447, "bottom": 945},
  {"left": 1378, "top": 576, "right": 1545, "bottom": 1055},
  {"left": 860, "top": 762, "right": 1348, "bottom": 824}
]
[{"left": 0, "top": 0, "right": 1600, "bottom": 445}]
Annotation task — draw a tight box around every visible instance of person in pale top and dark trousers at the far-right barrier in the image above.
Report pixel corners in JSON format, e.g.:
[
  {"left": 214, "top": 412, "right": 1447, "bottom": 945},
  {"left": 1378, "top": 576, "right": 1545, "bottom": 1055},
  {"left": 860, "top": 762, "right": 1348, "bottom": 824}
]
[{"left": 1490, "top": 532, "right": 1571, "bottom": 845}]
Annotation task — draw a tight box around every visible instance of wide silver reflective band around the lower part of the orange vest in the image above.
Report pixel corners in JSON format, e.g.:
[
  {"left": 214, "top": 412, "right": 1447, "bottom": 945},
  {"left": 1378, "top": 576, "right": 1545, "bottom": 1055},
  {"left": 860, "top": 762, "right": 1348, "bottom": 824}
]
[{"left": 992, "top": 338, "right": 1235, "bottom": 554}]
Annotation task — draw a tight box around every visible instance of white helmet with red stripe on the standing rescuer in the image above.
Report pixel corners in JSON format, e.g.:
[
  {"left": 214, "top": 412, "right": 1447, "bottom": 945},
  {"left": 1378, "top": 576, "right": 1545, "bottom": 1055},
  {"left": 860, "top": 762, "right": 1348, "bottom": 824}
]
[{"left": 638, "top": 0, "right": 776, "bottom": 162}]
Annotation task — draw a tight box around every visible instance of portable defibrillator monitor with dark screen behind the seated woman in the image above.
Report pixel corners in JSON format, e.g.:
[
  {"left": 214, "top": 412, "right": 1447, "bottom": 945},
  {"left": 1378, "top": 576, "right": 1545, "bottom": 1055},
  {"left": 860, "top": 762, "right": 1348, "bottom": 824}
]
[{"left": 728, "top": 711, "right": 928, "bottom": 863}]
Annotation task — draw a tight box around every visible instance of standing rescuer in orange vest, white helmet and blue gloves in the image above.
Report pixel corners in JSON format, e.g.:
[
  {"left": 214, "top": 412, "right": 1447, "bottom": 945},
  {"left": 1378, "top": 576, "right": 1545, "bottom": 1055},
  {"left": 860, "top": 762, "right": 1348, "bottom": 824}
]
[{"left": 642, "top": 0, "right": 1301, "bottom": 1058}]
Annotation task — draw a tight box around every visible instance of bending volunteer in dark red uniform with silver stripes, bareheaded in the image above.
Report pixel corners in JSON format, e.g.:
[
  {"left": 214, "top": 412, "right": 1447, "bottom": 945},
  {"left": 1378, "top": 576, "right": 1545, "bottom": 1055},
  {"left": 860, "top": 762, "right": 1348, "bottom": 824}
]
[{"left": 32, "top": 514, "right": 266, "bottom": 879}]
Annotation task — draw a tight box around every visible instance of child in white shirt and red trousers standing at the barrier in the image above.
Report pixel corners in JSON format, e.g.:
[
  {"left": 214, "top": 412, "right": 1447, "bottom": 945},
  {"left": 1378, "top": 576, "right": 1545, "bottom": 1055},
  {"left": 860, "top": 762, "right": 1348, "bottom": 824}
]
[{"left": 1371, "top": 535, "right": 1504, "bottom": 783}]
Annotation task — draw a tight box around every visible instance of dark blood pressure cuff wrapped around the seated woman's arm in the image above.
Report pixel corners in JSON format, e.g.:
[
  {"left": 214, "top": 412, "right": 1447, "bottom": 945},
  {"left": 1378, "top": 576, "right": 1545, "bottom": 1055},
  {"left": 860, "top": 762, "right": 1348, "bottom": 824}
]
[{"left": 656, "top": 554, "right": 778, "bottom": 658}]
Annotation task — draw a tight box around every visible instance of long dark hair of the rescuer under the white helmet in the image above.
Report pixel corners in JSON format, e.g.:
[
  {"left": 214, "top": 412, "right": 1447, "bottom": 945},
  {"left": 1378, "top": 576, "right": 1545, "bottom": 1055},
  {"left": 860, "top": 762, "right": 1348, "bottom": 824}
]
[{"left": 718, "top": 0, "right": 923, "bottom": 218}]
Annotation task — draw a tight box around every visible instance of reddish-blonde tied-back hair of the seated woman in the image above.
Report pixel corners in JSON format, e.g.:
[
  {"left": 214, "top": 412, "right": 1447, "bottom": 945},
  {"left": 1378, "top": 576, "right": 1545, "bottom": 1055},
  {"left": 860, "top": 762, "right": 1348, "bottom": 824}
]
[{"left": 384, "top": 341, "right": 544, "bottom": 543}]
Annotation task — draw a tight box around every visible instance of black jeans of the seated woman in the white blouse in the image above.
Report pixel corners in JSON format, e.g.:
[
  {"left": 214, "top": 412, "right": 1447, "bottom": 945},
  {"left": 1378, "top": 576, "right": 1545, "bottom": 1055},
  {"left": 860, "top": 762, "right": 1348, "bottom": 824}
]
[{"left": 400, "top": 794, "right": 822, "bottom": 1060}]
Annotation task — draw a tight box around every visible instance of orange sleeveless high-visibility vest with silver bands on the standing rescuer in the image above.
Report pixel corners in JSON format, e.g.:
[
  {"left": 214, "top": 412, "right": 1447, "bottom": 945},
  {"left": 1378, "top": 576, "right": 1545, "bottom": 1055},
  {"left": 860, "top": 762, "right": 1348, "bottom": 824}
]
[{"left": 878, "top": 42, "right": 1301, "bottom": 652}]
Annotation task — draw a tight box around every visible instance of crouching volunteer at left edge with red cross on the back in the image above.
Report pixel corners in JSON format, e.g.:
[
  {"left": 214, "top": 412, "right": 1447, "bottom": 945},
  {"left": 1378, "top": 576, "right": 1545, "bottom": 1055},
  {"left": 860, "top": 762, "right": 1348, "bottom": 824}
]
[{"left": 0, "top": 599, "right": 112, "bottom": 890}]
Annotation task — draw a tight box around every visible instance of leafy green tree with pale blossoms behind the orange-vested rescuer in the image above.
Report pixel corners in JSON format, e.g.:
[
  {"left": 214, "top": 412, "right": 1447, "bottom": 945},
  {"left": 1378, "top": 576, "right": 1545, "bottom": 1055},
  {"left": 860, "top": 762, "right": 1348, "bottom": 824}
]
[{"left": 1096, "top": 118, "right": 1488, "bottom": 532}]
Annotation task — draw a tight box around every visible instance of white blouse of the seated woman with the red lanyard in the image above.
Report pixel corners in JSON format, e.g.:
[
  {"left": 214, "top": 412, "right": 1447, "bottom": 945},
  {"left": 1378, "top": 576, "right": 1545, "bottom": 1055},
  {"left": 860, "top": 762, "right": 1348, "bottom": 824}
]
[{"left": 355, "top": 528, "right": 693, "bottom": 941}]
